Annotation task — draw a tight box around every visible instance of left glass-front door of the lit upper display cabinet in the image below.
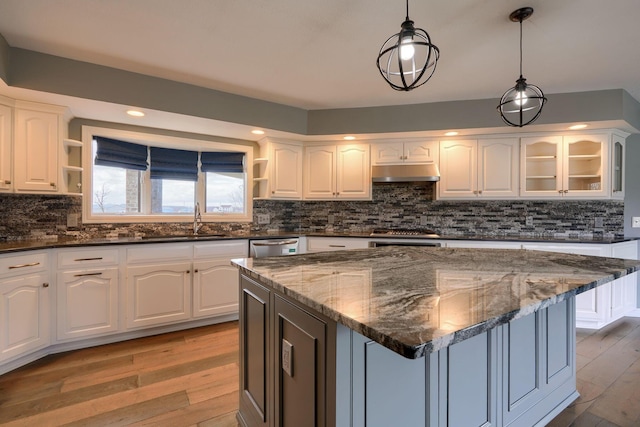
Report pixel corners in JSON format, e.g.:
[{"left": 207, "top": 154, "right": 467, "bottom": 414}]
[{"left": 520, "top": 136, "right": 563, "bottom": 198}]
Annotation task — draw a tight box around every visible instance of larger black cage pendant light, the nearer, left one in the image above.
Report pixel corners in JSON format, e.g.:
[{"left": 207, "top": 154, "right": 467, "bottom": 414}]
[{"left": 376, "top": 0, "right": 440, "bottom": 91}]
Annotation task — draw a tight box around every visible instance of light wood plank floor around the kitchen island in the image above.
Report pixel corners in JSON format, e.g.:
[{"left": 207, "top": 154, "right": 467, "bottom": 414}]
[{"left": 0, "top": 318, "right": 640, "bottom": 427}]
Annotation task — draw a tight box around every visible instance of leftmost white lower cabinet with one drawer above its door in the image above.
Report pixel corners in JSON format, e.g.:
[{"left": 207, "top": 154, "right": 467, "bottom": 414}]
[{"left": 0, "top": 252, "right": 50, "bottom": 362}]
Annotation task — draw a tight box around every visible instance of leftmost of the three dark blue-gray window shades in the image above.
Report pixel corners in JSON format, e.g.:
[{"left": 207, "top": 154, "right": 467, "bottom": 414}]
[{"left": 94, "top": 136, "right": 148, "bottom": 171}]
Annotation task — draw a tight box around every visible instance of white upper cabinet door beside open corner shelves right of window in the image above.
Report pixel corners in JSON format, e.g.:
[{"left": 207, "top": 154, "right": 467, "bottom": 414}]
[{"left": 269, "top": 143, "right": 302, "bottom": 199}]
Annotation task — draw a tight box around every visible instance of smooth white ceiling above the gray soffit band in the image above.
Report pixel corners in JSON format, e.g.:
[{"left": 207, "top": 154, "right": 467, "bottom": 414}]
[{"left": 0, "top": 0, "right": 640, "bottom": 136}]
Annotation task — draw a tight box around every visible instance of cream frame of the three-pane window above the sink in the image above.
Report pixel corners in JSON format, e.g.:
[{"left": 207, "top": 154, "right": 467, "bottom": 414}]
[{"left": 82, "top": 125, "right": 254, "bottom": 224}]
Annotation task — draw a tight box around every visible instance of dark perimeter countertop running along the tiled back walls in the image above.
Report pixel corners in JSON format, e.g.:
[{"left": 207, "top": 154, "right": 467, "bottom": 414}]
[{"left": 0, "top": 231, "right": 638, "bottom": 255}]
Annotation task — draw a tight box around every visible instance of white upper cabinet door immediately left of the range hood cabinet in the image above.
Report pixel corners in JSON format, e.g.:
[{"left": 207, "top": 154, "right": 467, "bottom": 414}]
[{"left": 336, "top": 145, "right": 371, "bottom": 199}]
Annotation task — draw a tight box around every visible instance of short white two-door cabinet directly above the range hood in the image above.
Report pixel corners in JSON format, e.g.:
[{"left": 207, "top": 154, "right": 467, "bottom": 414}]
[{"left": 371, "top": 141, "right": 438, "bottom": 165}]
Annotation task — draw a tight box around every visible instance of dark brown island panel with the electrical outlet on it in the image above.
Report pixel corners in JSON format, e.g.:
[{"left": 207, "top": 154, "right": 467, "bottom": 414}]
[{"left": 274, "top": 295, "right": 328, "bottom": 427}]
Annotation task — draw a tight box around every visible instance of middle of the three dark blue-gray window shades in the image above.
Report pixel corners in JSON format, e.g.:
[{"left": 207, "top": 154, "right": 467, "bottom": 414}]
[{"left": 151, "top": 147, "right": 198, "bottom": 181}]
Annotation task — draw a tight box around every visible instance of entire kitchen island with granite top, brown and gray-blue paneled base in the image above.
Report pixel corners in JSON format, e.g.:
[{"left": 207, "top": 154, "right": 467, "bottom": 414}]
[{"left": 233, "top": 247, "right": 640, "bottom": 427}]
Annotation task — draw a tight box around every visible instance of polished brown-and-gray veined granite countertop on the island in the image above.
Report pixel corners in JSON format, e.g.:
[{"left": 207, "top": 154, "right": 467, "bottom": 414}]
[{"left": 232, "top": 247, "right": 640, "bottom": 358}]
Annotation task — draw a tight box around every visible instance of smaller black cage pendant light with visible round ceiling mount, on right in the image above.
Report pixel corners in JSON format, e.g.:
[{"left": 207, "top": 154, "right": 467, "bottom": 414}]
[{"left": 498, "top": 7, "right": 547, "bottom": 127}]
